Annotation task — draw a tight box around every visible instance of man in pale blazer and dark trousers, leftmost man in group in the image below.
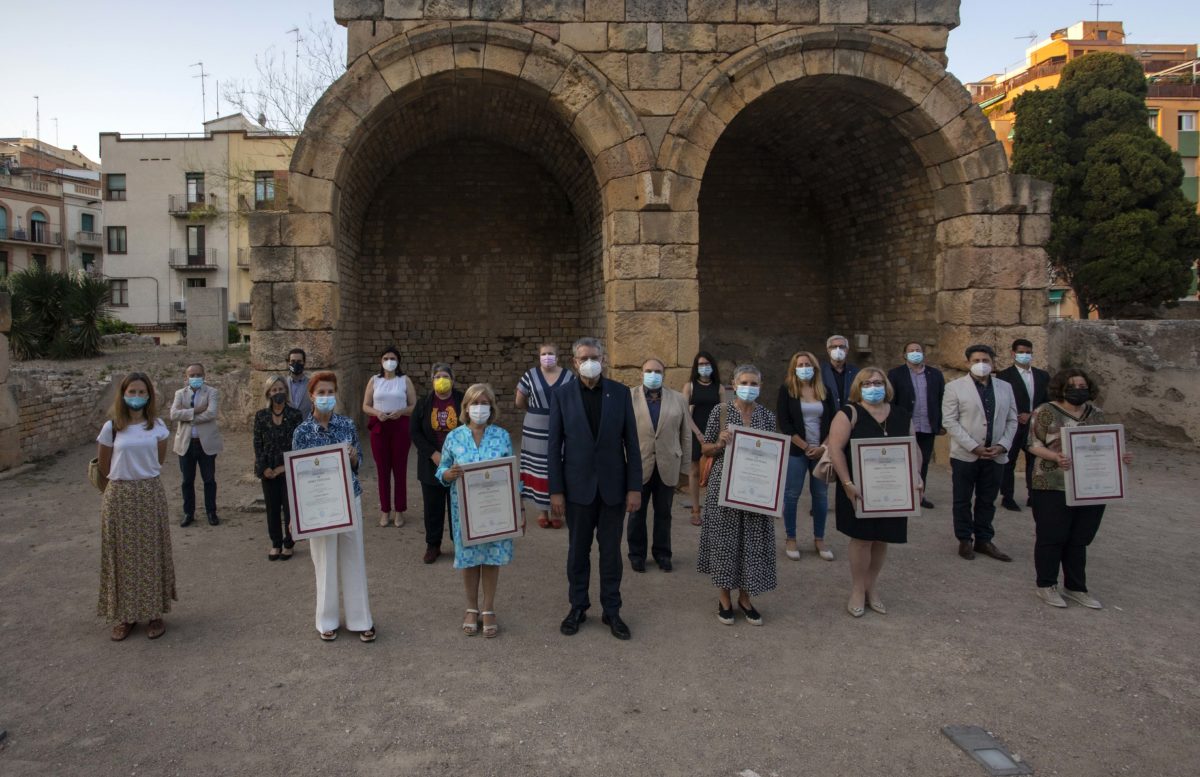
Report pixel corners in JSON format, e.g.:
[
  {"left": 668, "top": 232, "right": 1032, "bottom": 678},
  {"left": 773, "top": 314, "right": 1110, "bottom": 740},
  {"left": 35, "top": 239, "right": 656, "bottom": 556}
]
[{"left": 170, "top": 363, "right": 224, "bottom": 526}]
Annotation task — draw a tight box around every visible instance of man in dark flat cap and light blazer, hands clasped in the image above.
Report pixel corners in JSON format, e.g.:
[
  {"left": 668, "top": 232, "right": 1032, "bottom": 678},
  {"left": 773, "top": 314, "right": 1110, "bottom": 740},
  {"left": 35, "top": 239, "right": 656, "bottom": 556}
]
[{"left": 942, "top": 344, "right": 1016, "bottom": 561}]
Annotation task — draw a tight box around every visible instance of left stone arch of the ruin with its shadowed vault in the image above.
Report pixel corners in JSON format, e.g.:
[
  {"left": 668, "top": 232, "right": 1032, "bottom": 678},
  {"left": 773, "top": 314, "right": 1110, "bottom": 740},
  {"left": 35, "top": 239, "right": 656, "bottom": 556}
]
[{"left": 251, "top": 22, "right": 653, "bottom": 406}]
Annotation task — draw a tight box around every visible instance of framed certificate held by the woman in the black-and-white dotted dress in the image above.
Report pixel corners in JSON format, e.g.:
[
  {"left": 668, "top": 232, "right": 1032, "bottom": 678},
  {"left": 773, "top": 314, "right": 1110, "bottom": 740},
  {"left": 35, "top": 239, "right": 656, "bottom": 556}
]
[{"left": 716, "top": 426, "right": 791, "bottom": 518}]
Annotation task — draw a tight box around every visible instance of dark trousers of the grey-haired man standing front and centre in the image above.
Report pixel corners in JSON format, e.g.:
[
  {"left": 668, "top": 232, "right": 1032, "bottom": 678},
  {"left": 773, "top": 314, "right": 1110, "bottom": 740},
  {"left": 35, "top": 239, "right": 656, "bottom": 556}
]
[{"left": 566, "top": 494, "right": 625, "bottom": 615}]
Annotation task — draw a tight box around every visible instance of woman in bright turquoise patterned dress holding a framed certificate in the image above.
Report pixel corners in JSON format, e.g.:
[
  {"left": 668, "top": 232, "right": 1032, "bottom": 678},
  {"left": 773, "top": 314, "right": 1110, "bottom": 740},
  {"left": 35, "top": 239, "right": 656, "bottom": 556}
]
[{"left": 437, "top": 384, "right": 517, "bottom": 638}]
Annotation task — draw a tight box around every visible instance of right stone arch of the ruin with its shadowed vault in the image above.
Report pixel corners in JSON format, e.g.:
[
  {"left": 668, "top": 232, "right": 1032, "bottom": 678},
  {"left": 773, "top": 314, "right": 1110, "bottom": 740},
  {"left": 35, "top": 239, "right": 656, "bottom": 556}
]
[{"left": 656, "top": 28, "right": 1049, "bottom": 379}]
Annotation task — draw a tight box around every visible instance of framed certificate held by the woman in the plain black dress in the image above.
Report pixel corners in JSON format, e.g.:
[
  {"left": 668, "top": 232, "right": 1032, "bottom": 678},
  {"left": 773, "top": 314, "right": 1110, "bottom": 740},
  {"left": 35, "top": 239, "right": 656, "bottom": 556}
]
[{"left": 850, "top": 436, "right": 920, "bottom": 518}]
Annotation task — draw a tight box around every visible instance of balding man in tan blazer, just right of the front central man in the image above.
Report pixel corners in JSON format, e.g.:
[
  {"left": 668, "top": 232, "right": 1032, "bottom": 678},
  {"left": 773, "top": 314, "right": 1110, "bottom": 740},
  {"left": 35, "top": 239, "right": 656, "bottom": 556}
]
[{"left": 628, "top": 359, "right": 691, "bottom": 572}]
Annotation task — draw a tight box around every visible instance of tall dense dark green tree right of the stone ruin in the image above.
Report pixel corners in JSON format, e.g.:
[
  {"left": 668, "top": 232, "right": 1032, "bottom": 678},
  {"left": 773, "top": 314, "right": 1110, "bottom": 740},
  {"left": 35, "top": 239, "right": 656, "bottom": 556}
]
[{"left": 1013, "top": 53, "right": 1200, "bottom": 318}]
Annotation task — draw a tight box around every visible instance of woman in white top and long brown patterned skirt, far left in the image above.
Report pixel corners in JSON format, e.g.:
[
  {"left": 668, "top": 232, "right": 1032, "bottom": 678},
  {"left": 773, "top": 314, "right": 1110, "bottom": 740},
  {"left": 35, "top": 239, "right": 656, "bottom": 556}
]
[{"left": 96, "top": 373, "right": 175, "bottom": 642}]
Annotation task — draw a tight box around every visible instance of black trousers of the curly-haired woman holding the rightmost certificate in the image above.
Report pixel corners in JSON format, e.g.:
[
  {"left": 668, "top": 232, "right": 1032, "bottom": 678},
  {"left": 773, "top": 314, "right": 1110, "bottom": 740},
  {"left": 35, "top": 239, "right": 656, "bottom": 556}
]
[{"left": 1030, "top": 488, "right": 1104, "bottom": 591}]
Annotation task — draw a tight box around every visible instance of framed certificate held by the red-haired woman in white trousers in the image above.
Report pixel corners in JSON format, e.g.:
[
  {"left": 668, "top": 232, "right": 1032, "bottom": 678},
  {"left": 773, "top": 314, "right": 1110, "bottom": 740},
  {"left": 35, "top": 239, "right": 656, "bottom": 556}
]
[{"left": 283, "top": 444, "right": 362, "bottom": 540}]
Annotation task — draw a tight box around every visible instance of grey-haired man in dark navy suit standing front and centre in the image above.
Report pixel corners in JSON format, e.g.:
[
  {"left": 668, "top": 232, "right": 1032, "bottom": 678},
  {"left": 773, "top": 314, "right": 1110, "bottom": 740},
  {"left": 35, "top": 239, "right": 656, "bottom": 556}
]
[{"left": 547, "top": 337, "right": 642, "bottom": 639}]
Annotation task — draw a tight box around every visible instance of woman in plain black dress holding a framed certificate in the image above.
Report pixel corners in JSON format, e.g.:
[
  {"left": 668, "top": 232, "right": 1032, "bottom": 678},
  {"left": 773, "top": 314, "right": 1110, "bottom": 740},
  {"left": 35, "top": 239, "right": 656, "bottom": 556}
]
[{"left": 828, "top": 367, "right": 925, "bottom": 618}]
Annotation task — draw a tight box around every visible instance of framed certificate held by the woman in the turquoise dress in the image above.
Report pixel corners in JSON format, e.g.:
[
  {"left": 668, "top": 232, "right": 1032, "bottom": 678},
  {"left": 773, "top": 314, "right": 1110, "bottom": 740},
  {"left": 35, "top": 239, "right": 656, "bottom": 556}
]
[{"left": 455, "top": 456, "right": 522, "bottom": 546}]
